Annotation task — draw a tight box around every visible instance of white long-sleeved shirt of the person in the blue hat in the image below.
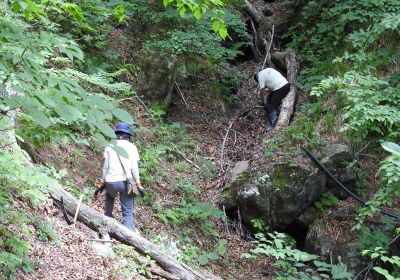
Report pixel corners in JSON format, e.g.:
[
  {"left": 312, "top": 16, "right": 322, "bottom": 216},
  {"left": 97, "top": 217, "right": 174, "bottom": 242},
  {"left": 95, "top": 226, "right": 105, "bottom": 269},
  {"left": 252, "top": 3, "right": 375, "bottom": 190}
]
[{"left": 103, "top": 140, "right": 140, "bottom": 183}]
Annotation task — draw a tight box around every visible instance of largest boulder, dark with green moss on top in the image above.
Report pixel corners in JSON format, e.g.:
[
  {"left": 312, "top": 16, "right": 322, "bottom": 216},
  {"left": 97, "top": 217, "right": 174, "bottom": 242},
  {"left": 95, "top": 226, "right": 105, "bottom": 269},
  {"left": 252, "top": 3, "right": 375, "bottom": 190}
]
[{"left": 238, "top": 164, "right": 326, "bottom": 229}]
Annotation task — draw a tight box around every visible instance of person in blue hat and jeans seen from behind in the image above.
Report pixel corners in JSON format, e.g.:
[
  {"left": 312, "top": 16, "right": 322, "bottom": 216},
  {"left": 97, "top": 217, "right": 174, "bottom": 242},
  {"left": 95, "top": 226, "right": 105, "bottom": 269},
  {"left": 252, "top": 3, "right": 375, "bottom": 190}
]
[{"left": 95, "top": 123, "right": 144, "bottom": 230}]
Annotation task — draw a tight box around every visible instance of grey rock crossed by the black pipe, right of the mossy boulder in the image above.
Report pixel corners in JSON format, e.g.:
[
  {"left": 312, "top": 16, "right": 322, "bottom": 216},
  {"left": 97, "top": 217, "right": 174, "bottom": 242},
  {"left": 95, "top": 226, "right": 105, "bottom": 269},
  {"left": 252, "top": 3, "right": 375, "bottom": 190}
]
[{"left": 321, "top": 144, "right": 358, "bottom": 199}]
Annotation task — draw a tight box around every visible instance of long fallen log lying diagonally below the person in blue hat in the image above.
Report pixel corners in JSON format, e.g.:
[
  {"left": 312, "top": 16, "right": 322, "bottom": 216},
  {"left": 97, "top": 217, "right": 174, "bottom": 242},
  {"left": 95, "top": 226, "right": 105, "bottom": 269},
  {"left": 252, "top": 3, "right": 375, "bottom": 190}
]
[{"left": 48, "top": 185, "right": 218, "bottom": 280}]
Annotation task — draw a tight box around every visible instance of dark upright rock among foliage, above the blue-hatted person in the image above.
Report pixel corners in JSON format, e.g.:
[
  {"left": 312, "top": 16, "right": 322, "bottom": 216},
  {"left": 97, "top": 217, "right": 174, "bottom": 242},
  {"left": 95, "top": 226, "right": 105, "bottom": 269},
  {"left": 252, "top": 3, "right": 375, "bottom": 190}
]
[{"left": 137, "top": 56, "right": 177, "bottom": 109}]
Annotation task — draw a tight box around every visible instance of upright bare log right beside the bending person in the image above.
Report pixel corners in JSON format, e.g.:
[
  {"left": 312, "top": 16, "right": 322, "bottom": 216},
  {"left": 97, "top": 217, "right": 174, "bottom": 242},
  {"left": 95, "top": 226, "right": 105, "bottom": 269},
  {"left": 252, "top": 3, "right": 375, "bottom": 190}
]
[{"left": 276, "top": 49, "right": 299, "bottom": 129}]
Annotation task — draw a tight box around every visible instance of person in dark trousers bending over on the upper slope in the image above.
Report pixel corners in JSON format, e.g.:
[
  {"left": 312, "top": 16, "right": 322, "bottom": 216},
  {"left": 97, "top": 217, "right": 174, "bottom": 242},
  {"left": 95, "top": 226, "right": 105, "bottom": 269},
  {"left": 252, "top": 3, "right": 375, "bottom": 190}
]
[{"left": 254, "top": 68, "right": 290, "bottom": 128}]
